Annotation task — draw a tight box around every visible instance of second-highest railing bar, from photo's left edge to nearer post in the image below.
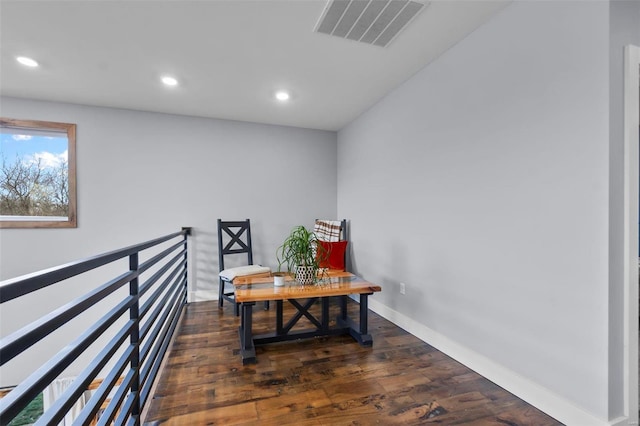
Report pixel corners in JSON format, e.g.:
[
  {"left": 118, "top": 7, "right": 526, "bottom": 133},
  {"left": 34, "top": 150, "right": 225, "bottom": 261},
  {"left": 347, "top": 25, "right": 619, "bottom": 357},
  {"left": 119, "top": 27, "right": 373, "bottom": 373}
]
[{"left": 0, "top": 271, "right": 137, "bottom": 365}]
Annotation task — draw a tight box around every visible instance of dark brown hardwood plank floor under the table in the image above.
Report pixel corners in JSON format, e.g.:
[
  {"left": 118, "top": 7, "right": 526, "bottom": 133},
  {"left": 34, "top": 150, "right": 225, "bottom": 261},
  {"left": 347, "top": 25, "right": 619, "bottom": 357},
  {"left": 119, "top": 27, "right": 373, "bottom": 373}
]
[{"left": 145, "top": 302, "right": 560, "bottom": 426}]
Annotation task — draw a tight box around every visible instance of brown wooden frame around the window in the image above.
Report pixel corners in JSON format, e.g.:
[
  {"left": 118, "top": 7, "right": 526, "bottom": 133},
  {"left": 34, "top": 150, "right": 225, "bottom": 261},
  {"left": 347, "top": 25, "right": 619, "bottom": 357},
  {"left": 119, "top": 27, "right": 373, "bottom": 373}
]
[{"left": 0, "top": 117, "right": 78, "bottom": 228}]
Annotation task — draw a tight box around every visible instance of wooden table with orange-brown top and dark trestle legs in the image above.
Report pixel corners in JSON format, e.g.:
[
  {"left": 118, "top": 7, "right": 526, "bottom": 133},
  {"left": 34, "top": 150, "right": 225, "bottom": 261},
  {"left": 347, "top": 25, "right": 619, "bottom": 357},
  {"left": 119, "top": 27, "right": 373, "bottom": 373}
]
[{"left": 233, "top": 271, "right": 382, "bottom": 364}]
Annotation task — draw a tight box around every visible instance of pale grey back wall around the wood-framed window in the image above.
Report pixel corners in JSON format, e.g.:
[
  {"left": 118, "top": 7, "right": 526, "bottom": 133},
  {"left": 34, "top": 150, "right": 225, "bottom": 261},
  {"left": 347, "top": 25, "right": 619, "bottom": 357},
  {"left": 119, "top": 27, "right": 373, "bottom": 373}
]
[{"left": 0, "top": 98, "right": 337, "bottom": 386}]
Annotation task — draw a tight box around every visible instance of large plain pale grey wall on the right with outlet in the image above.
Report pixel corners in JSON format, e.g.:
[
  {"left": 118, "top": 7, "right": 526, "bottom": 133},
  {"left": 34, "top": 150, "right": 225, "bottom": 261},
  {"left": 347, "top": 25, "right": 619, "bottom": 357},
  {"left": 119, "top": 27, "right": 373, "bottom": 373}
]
[{"left": 338, "top": 2, "right": 609, "bottom": 424}]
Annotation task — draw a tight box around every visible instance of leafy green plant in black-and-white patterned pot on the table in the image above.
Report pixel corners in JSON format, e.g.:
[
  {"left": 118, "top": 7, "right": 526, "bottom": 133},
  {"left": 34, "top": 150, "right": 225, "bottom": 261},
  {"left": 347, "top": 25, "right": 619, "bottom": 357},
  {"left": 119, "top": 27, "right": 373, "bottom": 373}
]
[{"left": 276, "top": 225, "right": 329, "bottom": 285}]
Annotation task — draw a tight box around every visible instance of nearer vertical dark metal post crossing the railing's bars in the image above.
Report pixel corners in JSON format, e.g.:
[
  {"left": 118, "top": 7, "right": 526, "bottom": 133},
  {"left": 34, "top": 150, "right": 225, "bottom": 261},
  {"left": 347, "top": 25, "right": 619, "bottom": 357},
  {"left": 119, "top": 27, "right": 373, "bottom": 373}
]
[{"left": 129, "top": 253, "right": 140, "bottom": 425}]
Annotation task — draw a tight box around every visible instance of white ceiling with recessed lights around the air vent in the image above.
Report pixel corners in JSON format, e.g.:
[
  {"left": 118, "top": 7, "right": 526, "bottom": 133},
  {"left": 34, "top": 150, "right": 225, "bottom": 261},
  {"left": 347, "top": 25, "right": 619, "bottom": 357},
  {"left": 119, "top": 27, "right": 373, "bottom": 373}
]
[{"left": 0, "top": 0, "right": 509, "bottom": 130}]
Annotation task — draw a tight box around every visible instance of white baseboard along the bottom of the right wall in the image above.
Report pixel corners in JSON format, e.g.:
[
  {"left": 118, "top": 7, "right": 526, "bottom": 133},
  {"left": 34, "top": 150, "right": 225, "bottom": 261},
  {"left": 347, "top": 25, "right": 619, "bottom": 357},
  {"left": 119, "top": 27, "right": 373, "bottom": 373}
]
[{"left": 369, "top": 298, "right": 616, "bottom": 426}]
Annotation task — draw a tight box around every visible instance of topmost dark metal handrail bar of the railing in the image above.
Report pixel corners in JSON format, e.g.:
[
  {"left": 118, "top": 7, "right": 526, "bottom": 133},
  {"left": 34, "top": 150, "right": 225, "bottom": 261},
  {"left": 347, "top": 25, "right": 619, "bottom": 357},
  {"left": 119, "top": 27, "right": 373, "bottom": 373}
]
[{"left": 0, "top": 229, "right": 189, "bottom": 303}]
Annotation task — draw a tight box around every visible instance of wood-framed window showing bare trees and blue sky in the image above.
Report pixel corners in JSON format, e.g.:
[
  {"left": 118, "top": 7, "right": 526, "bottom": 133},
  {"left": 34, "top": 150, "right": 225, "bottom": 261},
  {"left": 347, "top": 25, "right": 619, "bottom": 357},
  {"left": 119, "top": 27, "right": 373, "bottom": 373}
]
[{"left": 0, "top": 118, "right": 76, "bottom": 228}]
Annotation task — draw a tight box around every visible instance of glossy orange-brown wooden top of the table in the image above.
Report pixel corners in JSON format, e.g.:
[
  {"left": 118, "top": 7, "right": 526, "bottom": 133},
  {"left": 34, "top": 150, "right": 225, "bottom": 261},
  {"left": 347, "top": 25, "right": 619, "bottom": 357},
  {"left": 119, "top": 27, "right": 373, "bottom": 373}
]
[{"left": 233, "top": 271, "right": 382, "bottom": 303}]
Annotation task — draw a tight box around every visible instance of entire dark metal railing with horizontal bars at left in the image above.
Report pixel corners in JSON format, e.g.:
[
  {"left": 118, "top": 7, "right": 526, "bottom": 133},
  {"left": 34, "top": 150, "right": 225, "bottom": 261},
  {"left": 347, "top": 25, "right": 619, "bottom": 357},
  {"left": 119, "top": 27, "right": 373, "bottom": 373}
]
[{"left": 0, "top": 228, "right": 191, "bottom": 425}]
